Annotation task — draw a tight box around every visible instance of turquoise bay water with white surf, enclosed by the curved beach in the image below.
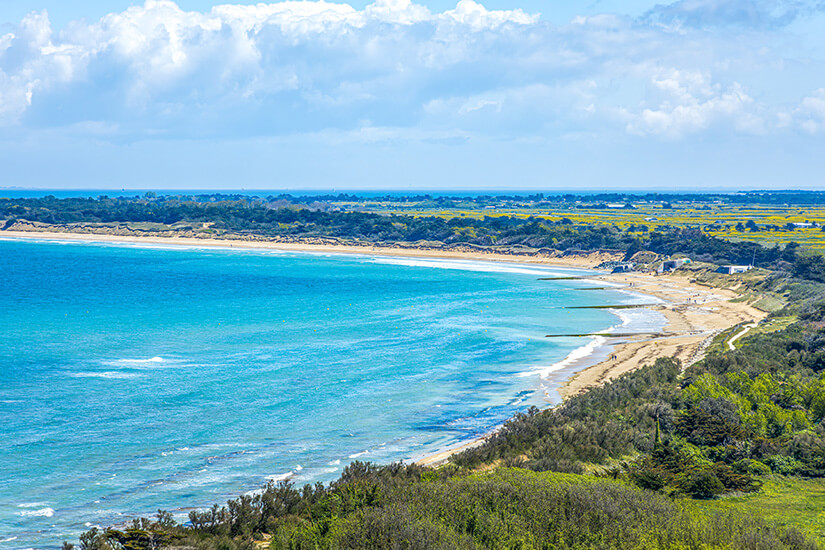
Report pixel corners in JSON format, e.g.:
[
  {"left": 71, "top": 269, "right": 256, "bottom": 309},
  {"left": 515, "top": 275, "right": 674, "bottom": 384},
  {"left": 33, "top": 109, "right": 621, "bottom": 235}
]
[{"left": 0, "top": 240, "right": 656, "bottom": 549}]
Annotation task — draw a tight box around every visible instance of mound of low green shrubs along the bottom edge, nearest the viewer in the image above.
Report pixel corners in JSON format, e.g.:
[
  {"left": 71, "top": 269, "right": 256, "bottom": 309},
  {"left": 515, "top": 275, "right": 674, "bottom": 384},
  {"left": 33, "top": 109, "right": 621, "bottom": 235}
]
[{"left": 75, "top": 470, "right": 818, "bottom": 550}]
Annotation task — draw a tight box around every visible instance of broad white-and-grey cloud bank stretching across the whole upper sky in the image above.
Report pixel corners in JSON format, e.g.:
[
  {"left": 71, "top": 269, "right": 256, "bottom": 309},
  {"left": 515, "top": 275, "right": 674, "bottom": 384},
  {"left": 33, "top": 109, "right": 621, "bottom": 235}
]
[{"left": 0, "top": 0, "right": 823, "bottom": 144}]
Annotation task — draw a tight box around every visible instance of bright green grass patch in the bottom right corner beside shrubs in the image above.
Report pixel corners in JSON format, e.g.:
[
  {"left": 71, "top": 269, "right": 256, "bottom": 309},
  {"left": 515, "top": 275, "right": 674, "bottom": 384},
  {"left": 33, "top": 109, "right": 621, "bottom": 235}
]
[{"left": 694, "top": 476, "right": 825, "bottom": 542}]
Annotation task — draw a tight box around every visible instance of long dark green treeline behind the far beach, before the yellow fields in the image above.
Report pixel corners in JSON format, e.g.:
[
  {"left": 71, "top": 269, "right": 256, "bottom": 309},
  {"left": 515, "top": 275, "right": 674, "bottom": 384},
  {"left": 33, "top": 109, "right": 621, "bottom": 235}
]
[{"left": 0, "top": 197, "right": 825, "bottom": 281}]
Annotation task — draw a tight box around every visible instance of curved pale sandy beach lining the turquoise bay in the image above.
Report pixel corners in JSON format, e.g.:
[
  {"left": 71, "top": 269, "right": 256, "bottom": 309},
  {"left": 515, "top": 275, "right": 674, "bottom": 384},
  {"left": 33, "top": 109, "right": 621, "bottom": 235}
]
[{"left": 0, "top": 231, "right": 767, "bottom": 465}]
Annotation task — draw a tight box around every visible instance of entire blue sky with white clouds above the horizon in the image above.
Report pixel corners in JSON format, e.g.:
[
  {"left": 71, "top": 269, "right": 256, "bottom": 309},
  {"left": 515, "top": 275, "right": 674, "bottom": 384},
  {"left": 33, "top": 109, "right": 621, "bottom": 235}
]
[{"left": 0, "top": 0, "right": 825, "bottom": 192}]
